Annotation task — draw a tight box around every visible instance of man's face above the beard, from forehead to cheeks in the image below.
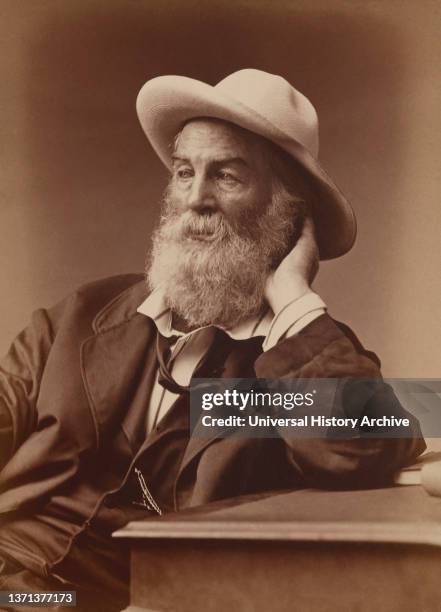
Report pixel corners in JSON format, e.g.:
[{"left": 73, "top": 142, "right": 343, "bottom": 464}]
[{"left": 170, "top": 119, "right": 271, "bottom": 234}]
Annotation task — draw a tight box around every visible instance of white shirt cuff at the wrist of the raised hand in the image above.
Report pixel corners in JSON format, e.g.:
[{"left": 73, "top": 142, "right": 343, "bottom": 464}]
[{"left": 262, "top": 291, "right": 326, "bottom": 351}]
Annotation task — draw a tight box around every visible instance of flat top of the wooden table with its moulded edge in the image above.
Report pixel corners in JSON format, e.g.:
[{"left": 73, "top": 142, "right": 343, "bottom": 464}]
[{"left": 114, "top": 486, "right": 441, "bottom": 546}]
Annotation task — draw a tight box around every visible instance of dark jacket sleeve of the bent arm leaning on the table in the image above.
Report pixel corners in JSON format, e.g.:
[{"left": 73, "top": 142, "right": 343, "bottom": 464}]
[{"left": 255, "top": 314, "right": 425, "bottom": 488}]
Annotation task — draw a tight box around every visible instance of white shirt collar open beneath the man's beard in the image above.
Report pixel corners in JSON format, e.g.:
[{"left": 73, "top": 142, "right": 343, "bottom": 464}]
[{"left": 137, "top": 287, "right": 273, "bottom": 340}]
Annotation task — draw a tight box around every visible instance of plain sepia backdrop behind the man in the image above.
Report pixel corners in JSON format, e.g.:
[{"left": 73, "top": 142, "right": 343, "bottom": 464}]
[{"left": 0, "top": 0, "right": 441, "bottom": 377}]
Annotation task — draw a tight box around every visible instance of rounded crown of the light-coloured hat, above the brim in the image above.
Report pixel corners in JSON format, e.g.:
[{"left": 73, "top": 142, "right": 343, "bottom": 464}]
[{"left": 214, "top": 68, "right": 319, "bottom": 157}]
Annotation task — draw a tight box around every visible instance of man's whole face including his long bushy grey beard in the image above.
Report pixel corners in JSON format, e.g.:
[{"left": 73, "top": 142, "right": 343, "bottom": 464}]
[{"left": 148, "top": 119, "right": 296, "bottom": 329}]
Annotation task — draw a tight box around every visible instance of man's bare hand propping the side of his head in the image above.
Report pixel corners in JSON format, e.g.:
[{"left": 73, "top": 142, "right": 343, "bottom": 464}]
[{"left": 265, "top": 217, "right": 319, "bottom": 313}]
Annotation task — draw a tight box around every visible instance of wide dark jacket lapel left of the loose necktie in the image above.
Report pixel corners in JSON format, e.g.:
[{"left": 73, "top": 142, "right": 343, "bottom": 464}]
[{"left": 81, "top": 283, "right": 156, "bottom": 451}]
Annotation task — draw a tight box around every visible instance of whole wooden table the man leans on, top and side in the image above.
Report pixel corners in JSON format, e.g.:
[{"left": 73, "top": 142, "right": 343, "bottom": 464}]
[{"left": 115, "top": 486, "right": 441, "bottom": 612}]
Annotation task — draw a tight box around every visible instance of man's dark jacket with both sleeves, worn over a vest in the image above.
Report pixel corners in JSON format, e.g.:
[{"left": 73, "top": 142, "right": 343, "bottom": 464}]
[{"left": 0, "top": 275, "right": 424, "bottom": 522}]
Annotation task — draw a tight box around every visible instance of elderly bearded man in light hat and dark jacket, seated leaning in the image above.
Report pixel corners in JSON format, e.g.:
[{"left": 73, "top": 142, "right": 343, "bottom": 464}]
[{"left": 0, "top": 70, "right": 424, "bottom": 610}]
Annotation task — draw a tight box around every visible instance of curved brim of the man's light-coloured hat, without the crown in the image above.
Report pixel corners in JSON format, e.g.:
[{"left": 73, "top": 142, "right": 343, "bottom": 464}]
[{"left": 136, "top": 76, "right": 357, "bottom": 260}]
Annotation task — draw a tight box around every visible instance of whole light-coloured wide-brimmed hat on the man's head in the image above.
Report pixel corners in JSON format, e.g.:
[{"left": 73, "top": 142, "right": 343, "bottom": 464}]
[{"left": 136, "top": 69, "right": 357, "bottom": 259}]
